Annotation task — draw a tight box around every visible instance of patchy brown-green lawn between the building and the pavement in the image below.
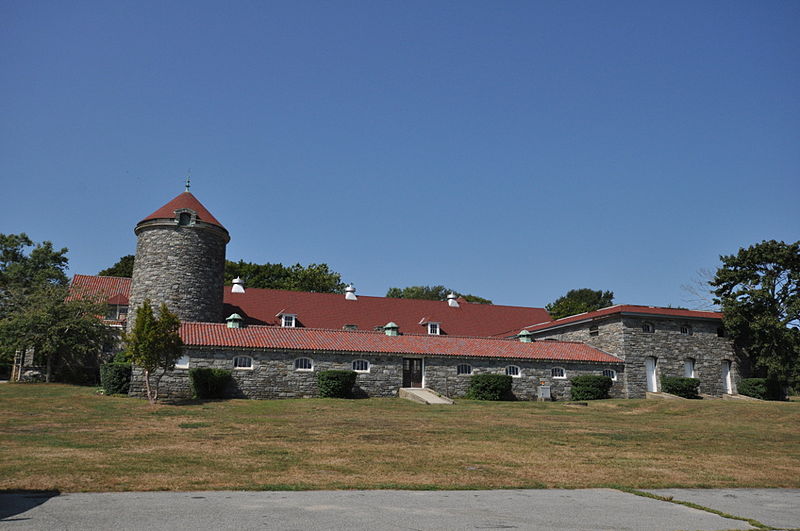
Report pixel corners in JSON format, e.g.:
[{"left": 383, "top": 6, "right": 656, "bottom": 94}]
[{"left": 0, "top": 384, "right": 800, "bottom": 492}]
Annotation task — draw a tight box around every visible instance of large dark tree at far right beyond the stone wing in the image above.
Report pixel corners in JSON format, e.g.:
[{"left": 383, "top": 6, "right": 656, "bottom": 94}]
[{"left": 710, "top": 240, "right": 800, "bottom": 383}]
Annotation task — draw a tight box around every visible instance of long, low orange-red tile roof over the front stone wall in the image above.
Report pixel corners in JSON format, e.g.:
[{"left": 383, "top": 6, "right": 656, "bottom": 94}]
[{"left": 180, "top": 323, "right": 622, "bottom": 363}]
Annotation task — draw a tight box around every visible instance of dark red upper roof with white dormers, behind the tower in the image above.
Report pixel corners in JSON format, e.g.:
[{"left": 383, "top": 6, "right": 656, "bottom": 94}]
[{"left": 225, "top": 286, "right": 550, "bottom": 337}]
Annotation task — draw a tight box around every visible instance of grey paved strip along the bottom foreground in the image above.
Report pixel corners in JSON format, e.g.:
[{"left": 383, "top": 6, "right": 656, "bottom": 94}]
[{"left": 0, "top": 489, "right": 800, "bottom": 531}]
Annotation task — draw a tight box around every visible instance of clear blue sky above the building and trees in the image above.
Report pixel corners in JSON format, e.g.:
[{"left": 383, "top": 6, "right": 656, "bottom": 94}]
[{"left": 0, "top": 0, "right": 800, "bottom": 306}]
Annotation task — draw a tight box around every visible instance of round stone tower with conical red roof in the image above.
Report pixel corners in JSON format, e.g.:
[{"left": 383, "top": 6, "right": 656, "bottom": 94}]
[{"left": 128, "top": 187, "right": 231, "bottom": 330}]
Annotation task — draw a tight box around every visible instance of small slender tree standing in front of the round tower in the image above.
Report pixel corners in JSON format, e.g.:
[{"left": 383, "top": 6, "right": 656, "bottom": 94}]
[{"left": 125, "top": 299, "right": 183, "bottom": 404}]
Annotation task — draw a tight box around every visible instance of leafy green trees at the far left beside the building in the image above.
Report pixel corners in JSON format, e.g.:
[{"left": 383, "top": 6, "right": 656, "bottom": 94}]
[{"left": 0, "top": 233, "right": 113, "bottom": 381}]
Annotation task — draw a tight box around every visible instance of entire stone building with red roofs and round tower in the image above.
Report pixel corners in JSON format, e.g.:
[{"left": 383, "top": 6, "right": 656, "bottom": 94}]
[{"left": 72, "top": 188, "right": 736, "bottom": 400}]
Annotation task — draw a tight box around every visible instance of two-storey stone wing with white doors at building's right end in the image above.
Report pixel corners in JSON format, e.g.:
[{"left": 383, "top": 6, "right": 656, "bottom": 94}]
[{"left": 533, "top": 314, "right": 739, "bottom": 398}]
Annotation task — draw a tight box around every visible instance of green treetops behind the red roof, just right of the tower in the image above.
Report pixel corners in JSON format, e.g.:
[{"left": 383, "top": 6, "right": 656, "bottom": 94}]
[{"left": 225, "top": 260, "right": 346, "bottom": 293}]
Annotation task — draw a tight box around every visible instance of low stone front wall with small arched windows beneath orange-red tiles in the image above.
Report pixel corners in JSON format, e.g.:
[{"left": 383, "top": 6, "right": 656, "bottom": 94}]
[{"left": 130, "top": 348, "right": 624, "bottom": 400}]
